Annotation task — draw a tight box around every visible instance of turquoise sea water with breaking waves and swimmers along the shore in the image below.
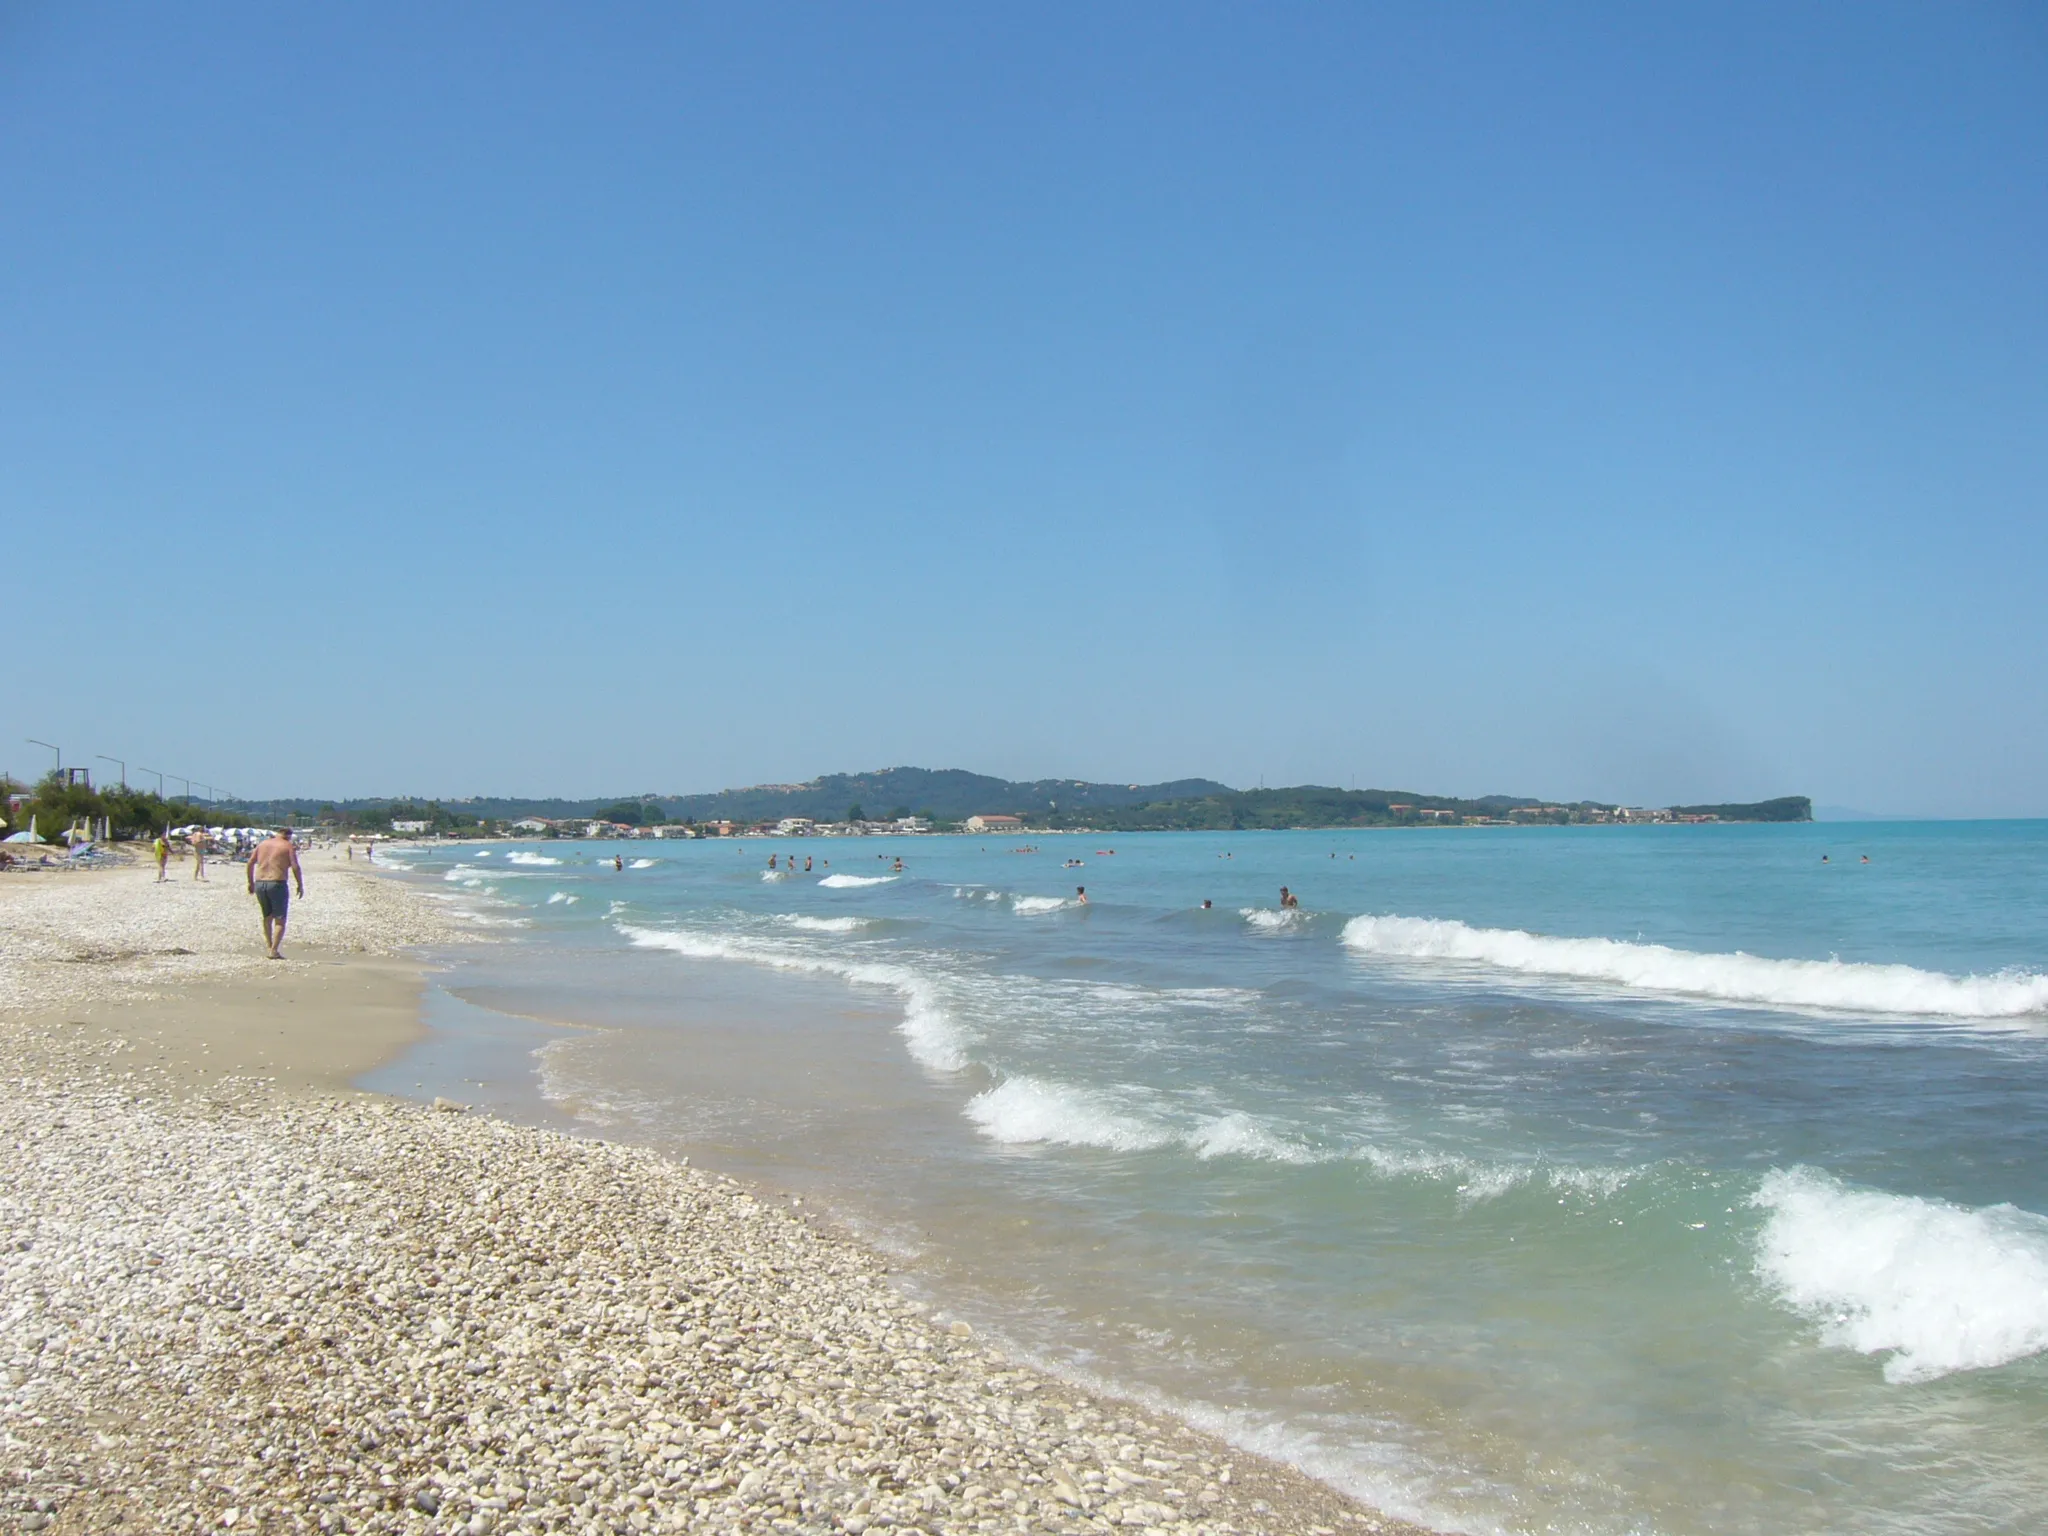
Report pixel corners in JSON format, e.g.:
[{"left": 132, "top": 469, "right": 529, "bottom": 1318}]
[{"left": 387, "top": 823, "right": 2048, "bottom": 1536}]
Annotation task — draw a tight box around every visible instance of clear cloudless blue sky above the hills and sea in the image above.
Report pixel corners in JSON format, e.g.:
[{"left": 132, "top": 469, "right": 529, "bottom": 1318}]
[{"left": 0, "top": 4, "right": 2048, "bottom": 815}]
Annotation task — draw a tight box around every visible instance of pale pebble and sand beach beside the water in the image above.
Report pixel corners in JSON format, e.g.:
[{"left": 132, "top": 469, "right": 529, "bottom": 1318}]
[{"left": 0, "top": 854, "right": 1409, "bottom": 1534}]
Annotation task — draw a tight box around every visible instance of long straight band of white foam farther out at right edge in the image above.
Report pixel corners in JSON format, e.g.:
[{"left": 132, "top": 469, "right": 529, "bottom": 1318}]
[{"left": 1343, "top": 915, "right": 2048, "bottom": 1018}]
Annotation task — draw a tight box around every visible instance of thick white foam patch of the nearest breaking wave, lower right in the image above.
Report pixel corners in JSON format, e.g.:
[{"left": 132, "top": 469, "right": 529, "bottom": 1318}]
[{"left": 1755, "top": 1167, "right": 2048, "bottom": 1382}]
